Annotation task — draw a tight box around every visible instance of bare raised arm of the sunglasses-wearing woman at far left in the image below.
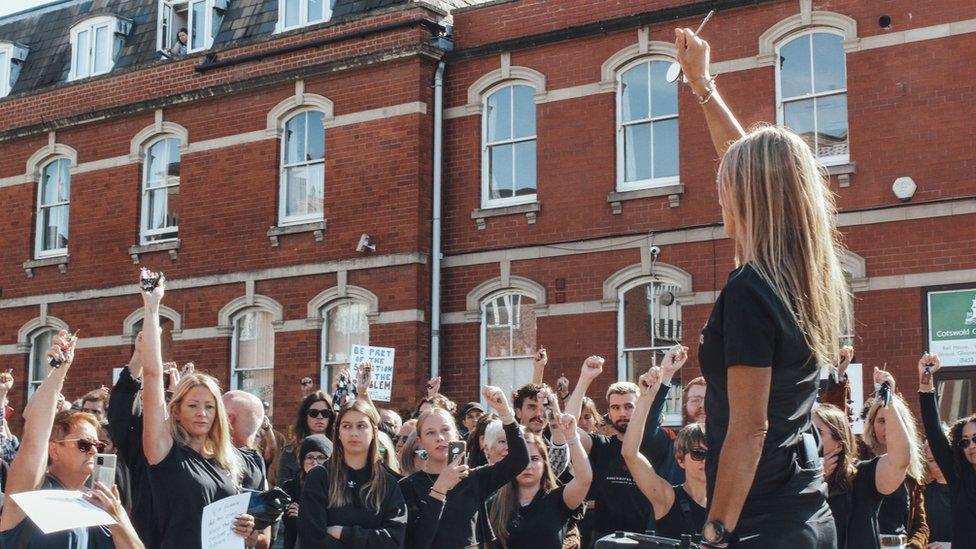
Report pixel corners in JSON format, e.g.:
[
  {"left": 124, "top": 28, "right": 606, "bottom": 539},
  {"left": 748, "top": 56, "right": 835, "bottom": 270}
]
[{"left": 0, "top": 330, "right": 75, "bottom": 532}]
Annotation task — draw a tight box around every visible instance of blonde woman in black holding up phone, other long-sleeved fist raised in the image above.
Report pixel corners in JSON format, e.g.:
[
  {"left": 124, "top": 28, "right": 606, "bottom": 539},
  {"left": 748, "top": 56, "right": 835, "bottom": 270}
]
[{"left": 400, "top": 386, "right": 529, "bottom": 549}]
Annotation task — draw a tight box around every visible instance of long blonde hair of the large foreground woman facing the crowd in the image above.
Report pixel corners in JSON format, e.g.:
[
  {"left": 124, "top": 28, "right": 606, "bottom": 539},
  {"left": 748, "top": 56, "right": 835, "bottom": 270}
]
[{"left": 718, "top": 126, "right": 851, "bottom": 364}]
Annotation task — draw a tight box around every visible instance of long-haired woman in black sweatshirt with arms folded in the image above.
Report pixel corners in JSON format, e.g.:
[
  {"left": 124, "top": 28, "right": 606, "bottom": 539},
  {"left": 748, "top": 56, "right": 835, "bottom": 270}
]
[{"left": 298, "top": 399, "right": 407, "bottom": 549}]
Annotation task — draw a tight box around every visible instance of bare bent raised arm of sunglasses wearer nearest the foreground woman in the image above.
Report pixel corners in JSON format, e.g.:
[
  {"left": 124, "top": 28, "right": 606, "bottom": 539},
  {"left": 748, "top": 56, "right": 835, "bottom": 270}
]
[{"left": 620, "top": 366, "right": 674, "bottom": 518}]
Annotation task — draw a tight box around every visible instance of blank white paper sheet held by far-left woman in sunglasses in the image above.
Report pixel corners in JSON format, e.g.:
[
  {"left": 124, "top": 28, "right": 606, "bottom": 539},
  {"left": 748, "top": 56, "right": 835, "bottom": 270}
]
[{"left": 8, "top": 490, "right": 116, "bottom": 534}]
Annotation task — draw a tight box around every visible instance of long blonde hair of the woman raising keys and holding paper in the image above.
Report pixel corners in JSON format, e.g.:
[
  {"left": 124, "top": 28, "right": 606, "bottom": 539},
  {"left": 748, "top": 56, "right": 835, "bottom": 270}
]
[{"left": 169, "top": 372, "right": 242, "bottom": 484}]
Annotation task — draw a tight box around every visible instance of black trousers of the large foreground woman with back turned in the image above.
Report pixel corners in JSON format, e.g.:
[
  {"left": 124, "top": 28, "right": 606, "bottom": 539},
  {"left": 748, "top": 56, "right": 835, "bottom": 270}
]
[{"left": 730, "top": 500, "right": 837, "bottom": 549}]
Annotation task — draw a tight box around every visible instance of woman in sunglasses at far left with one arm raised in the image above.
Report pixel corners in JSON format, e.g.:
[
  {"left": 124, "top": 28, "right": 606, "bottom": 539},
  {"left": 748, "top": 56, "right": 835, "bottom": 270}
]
[{"left": 0, "top": 330, "right": 143, "bottom": 549}]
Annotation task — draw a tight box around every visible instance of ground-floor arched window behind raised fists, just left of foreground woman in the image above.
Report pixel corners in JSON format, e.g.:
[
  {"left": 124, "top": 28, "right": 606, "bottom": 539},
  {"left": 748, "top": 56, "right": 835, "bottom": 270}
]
[{"left": 618, "top": 282, "right": 682, "bottom": 424}]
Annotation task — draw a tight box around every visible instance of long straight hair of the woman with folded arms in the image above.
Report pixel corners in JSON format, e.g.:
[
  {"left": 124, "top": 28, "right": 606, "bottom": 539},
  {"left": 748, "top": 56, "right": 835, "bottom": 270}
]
[{"left": 329, "top": 398, "right": 393, "bottom": 512}]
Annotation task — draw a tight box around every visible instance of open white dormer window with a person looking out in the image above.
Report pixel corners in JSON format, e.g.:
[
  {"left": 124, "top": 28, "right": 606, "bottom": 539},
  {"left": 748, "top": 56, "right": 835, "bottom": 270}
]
[{"left": 156, "top": 0, "right": 227, "bottom": 57}]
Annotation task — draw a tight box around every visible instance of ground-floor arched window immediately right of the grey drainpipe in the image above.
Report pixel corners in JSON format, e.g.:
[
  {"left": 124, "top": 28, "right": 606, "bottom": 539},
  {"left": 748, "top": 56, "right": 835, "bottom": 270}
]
[{"left": 481, "top": 293, "right": 536, "bottom": 395}]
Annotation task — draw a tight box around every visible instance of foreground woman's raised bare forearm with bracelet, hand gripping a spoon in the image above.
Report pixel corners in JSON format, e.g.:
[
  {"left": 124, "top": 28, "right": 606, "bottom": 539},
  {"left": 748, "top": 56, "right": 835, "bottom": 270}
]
[{"left": 674, "top": 29, "right": 746, "bottom": 158}]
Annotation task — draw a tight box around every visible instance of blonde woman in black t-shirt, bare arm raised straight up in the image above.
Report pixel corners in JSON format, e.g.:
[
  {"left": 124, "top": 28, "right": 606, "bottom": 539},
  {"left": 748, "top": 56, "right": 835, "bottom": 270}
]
[{"left": 142, "top": 275, "right": 261, "bottom": 549}]
